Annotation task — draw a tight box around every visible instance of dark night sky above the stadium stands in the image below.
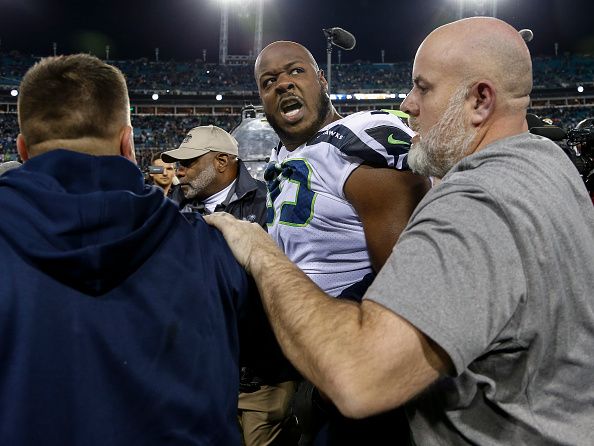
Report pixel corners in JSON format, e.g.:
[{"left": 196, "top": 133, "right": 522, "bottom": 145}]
[{"left": 0, "top": 0, "right": 594, "bottom": 62}]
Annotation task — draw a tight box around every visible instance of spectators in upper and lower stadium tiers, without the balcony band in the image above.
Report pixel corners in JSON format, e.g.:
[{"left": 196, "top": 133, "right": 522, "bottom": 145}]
[{"left": 0, "top": 51, "right": 594, "bottom": 169}]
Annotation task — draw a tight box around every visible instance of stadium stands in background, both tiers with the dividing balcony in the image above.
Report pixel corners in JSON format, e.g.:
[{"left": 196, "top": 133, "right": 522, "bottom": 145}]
[{"left": 0, "top": 51, "right": 594, "bottom": 168}]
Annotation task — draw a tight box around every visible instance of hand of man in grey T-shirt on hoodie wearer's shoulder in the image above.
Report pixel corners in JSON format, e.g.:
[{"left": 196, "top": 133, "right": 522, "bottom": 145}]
[{"left": 204, "top": 212, "right": 276, "bottom": 273}]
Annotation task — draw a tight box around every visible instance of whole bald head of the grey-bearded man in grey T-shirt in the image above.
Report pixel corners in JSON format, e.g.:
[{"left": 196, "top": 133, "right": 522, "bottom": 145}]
[{"left": 400, "top": 17, "right": 532, "bottom": 178}]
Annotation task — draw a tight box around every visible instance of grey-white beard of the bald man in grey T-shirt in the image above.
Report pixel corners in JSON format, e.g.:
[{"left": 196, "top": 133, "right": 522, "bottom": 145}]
[{"left": 408, "top": 87, "right": 477, "bottom": 178}]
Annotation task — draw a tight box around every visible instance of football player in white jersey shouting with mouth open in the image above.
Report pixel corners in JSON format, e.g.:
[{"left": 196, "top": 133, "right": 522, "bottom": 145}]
[{"left": 255, "top": 41, "right": 430, "bottom": 444}]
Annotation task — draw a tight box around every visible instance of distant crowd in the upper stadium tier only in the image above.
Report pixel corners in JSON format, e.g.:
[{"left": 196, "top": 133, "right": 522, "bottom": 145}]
[{"left": 0, "top": 51, "right": 594, "bottom": 94}]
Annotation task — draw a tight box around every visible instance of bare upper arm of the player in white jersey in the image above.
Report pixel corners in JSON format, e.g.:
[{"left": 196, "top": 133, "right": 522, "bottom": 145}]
[{"left": 344, "top": 165, "right": 431, "bottom": 271}]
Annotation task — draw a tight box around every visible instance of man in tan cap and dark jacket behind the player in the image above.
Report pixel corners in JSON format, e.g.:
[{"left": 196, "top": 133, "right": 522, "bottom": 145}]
[{"left": 161, "top": 125, "right": 298, "bottom": 446}]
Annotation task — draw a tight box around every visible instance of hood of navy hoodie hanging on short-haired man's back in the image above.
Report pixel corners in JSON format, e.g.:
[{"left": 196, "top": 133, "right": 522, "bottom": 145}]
[{"left": 0, "top": 149, "right": 179, "bottom": 296}]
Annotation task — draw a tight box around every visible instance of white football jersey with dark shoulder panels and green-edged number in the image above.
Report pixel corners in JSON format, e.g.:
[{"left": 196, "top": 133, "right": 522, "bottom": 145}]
[{"left": 266, "top": 111, "right": 413, "bottom": 296}]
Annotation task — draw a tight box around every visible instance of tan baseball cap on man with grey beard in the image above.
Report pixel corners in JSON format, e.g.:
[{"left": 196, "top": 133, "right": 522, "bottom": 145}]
[{"left": 161, "top": 125, "right": 239, "bottom": 163}]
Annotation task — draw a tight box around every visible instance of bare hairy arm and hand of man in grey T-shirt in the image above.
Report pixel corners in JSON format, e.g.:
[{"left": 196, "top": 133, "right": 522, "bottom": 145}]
[{"left": 205, "top": 213, "right": 449, "bottom": 418}]
